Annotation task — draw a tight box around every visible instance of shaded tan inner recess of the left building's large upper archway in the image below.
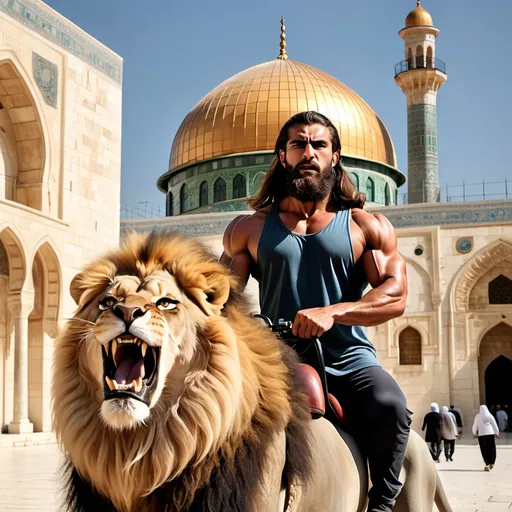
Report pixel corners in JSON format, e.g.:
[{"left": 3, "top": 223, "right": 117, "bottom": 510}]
[{"left": 0, "top": 59, "right": 49, "bottom": 211}]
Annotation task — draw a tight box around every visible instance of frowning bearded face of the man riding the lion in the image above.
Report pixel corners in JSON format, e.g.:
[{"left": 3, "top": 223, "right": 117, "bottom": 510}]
[{"left": 279, "top": 124, "right": 339, "bottom": 201}]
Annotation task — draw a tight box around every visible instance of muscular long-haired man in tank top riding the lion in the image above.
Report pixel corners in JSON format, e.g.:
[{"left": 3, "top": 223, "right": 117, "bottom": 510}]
[{"left": 221, "top": 112, "right": 410, "bottom": 511}]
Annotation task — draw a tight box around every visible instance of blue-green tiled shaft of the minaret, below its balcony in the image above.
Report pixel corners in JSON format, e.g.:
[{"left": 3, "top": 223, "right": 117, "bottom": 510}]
[{"left": 407, "top": 104, "right": 440, "bottom": 203}]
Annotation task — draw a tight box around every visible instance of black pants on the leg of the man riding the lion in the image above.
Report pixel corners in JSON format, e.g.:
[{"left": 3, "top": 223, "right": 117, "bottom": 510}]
[{"left": 327, "top": 366, "right": 411, "bottom": 511}]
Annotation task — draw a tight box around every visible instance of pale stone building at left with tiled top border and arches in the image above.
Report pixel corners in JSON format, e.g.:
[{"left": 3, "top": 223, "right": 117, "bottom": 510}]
[{"left": 0, "top": 0, "right": 122, "bottom": 437}]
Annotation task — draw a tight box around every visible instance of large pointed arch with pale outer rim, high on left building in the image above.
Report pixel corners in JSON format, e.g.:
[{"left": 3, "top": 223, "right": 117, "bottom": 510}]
[{"left": 0, "top": 56, "right": 48, "bottom": 214}]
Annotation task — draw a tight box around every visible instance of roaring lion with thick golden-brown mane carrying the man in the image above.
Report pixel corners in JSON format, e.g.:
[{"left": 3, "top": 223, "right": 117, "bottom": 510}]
[{"left": 52, "top": 232, "right": 450, "bottom": 512}]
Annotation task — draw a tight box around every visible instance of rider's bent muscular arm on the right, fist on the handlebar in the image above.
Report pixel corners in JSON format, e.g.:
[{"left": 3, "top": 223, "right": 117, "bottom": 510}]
[{"left": 293, "top": 211, "right": 407, "bottom": 338}]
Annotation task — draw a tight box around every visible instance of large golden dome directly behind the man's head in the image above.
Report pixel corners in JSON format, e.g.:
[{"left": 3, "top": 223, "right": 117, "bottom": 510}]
[{"left": 169, "top": 59, "right": 396, "bottom": 169}]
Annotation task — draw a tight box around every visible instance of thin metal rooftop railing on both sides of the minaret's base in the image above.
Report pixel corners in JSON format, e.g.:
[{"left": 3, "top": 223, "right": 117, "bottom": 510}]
[{"left": 399, "top": 178, "right": 512, "bottom": 204}]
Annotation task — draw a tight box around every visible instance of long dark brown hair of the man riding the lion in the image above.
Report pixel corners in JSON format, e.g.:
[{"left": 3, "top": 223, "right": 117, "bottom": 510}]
[{"left": 248, "top": 111, "right": 366, "bottom": 210}]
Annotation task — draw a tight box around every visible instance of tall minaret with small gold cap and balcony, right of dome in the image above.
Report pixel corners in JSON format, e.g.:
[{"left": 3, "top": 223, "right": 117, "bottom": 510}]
[{"left": 395, "top": 0, "right": 446, "bottom": 203}]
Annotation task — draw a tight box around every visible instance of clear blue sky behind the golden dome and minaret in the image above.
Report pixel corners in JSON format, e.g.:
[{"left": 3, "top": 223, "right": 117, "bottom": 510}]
[{"left": 47, "top": 0, "right": 512, "bottom": 208}]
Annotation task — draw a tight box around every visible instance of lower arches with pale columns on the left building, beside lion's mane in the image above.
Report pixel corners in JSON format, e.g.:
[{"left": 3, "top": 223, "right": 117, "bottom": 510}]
[{"left": 0, "top": 232, "right": 61, "bottom": 433}]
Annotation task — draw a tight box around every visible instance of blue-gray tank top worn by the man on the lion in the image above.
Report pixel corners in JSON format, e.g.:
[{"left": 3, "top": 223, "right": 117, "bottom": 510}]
[{"left": 257, "top": 203, "right": 380, "bottom": 375}]
